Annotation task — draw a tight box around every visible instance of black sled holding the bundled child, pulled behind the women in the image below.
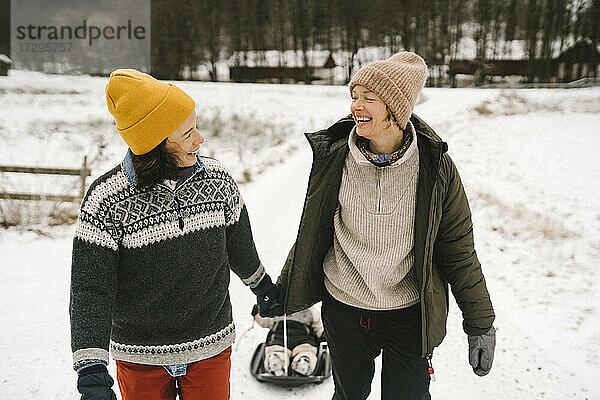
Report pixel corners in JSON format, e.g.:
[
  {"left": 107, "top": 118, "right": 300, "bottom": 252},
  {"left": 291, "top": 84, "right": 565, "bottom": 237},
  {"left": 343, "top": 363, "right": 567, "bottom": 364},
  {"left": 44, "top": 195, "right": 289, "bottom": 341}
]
[{"left": 250, "top": 342, "right": 331, "bottom": 387}]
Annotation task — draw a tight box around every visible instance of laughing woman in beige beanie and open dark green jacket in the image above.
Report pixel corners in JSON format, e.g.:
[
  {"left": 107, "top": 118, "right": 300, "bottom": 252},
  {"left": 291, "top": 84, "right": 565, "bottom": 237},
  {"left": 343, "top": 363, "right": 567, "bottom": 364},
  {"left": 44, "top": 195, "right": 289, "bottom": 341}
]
[{"left": 278, "top": 52, "right": 495, "bottom": 400}]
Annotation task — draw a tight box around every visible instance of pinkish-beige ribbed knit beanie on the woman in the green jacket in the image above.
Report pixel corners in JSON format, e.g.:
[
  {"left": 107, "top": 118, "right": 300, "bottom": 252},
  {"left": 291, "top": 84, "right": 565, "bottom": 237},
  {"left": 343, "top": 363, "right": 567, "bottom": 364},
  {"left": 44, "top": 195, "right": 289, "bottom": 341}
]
[{"left": 350, "top": 51, "right": 427, "bottom": 129}]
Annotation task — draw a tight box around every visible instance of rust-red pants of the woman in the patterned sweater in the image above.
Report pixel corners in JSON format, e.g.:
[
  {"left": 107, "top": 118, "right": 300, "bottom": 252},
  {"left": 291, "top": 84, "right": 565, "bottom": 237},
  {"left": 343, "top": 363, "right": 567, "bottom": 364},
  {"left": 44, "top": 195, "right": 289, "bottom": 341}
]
[{"left": 116, "top": 347, "right": 231, "bottom": 400}]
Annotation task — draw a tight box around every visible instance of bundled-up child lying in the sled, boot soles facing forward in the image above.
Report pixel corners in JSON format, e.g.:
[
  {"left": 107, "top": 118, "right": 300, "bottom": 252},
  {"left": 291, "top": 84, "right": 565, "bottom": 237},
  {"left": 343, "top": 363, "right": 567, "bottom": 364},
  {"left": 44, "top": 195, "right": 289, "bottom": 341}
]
[{"left": 252, "top": 306, "right": 323, "bottom": 376}]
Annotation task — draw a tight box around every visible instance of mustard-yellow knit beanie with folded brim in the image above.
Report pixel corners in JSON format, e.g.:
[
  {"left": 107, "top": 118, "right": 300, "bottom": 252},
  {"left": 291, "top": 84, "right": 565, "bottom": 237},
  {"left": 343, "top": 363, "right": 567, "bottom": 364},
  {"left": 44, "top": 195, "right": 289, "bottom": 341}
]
[{"left": 106, "top": 69, "right": 195, "bottom": 155}]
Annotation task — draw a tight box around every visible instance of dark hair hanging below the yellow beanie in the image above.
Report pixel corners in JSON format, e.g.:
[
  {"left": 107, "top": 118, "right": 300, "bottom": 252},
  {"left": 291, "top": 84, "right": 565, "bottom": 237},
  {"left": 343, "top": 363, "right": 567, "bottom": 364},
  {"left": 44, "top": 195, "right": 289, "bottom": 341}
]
[{"left": 132, "top": 139, "right": 177, "bottom": 189}]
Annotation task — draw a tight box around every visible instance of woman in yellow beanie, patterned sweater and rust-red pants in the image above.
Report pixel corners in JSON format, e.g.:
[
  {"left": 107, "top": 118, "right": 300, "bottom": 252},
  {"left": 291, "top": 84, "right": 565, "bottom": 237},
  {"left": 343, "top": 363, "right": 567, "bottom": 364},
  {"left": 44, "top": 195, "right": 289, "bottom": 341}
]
[{"left": 70, "top": 69, "right": 282, "bottom": 400}]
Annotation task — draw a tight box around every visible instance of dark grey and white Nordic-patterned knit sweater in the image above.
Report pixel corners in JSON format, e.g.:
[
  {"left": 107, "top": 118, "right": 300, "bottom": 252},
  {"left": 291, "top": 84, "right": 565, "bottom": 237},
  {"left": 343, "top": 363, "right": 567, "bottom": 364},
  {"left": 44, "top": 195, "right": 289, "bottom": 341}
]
[{"left": 70, "top": 153, "right": 264, "bottom": 369}]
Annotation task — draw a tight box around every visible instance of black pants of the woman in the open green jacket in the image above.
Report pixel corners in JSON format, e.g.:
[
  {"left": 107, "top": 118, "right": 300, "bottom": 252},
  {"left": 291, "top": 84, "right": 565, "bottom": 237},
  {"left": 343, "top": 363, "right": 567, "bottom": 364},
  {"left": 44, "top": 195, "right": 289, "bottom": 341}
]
[{"left": 321, "top": 291, "right": 431, "bottom": 400}]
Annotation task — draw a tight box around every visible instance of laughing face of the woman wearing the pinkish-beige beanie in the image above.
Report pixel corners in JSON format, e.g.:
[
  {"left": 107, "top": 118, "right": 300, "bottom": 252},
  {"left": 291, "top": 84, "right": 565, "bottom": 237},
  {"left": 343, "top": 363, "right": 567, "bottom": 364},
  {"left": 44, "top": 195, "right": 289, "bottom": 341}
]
[{"left": 350, "top": 85, "right": 390, "bottom": 139}]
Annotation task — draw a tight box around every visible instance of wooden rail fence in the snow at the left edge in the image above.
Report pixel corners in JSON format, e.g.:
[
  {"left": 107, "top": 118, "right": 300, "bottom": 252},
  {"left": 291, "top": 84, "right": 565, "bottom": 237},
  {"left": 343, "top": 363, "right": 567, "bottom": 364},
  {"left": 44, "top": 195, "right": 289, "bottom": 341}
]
[{"left": 0, "top": 157, "right": 91, "bottom": 203}]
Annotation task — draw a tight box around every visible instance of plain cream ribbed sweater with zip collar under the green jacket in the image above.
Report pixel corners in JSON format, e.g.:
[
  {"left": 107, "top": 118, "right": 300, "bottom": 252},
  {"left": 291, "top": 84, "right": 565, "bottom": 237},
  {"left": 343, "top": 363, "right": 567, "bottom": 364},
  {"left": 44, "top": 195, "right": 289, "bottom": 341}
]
[{"left": 323, "top": 122, "right": 419, "bottom": 310}]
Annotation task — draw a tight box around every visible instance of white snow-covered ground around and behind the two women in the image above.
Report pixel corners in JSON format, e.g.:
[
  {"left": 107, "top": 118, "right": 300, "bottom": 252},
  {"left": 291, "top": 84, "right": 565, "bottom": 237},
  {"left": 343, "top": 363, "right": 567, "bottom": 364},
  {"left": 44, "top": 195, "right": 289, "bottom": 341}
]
[{"left": 0, "top": 71, "right": 600, "bottom": 400}]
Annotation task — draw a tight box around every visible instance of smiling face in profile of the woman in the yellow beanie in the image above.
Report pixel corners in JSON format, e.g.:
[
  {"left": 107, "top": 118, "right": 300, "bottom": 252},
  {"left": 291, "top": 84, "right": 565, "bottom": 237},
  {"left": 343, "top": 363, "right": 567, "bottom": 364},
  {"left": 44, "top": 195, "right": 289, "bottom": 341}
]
[{"left": 165, "top": 111, "right": 204, "bottom": 167}]
